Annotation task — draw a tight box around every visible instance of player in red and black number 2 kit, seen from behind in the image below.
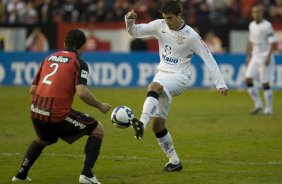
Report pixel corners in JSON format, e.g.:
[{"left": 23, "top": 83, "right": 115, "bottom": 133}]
[{"left": 12, "top": 29, "right": 111, "bottom": 184}]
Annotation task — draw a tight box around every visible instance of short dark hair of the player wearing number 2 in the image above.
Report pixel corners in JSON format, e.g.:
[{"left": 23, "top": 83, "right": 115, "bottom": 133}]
[{"left": 65, "top": 29, "right": 86, "bottom": 50}]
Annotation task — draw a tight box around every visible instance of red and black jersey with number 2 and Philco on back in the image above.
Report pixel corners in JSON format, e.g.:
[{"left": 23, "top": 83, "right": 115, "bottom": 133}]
[{"left": 31, "top": 50, "right": 89, "bottom": 122}]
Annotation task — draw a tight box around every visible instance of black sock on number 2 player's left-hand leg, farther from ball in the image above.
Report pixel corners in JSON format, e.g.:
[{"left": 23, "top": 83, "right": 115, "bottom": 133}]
[{"left": 16, "top": 141, "right": 45, "bottom": 179}]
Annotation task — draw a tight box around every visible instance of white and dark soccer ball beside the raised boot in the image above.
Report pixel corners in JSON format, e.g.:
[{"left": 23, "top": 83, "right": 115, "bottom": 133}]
[{"left": 111, "top": 106, "right": 134, "bottom": 128}]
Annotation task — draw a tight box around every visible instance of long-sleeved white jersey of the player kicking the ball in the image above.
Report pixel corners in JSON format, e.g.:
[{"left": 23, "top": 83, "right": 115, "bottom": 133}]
[{"left": 125, "top": 16, "right": 227, "bottom": 89}]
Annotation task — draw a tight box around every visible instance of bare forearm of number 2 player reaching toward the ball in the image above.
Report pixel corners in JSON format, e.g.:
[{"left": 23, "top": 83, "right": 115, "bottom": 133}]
[{"left": 75, "top": 84, "right": 111, "bottom": 114}]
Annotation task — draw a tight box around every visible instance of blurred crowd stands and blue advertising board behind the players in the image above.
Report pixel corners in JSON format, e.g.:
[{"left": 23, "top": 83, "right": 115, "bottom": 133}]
[{"left": 0, "top": 0, "right": 282, "bottom": 89}]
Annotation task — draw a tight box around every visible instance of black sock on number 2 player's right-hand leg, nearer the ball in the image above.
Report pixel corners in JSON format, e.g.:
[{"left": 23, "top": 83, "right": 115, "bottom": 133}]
[{"left": 82, "top": 136, "right": 102, "bottom": 178}]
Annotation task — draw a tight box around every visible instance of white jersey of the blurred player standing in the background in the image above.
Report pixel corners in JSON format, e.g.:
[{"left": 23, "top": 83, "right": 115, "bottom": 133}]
[{"left": 249, "top": 20, "right": 276, "bottom": 61}]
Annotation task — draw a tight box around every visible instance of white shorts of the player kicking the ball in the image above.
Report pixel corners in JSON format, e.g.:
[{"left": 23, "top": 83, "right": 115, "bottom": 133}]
[{"left": 153, "top": 71, "right": 190, "bottom": 119}]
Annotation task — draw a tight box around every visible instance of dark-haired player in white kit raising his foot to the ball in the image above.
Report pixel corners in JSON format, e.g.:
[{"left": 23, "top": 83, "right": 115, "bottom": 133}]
[{"left": 125, "top": 1, "right": 228, "bottom": 172}]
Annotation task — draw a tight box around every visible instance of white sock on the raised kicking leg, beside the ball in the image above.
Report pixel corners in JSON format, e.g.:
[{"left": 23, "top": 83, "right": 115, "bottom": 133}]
[{"left": 140, "top": 96, "right": 159, "bottom": 129}]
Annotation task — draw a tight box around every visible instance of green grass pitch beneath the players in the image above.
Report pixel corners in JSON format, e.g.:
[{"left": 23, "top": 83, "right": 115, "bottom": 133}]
[{"left": 0, "top": 87, "right": 282, "bottom": 184}]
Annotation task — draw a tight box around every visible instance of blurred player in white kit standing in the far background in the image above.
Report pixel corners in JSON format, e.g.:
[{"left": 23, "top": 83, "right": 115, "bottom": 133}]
[{"left": 245, "top": 5, "right": 276, "bottom": 115}]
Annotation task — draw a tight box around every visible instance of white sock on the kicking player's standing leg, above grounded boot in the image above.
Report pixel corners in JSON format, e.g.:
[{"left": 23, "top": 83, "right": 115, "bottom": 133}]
[{"left": 157, "top": 132, "right": 180, "bottom": 164}]
